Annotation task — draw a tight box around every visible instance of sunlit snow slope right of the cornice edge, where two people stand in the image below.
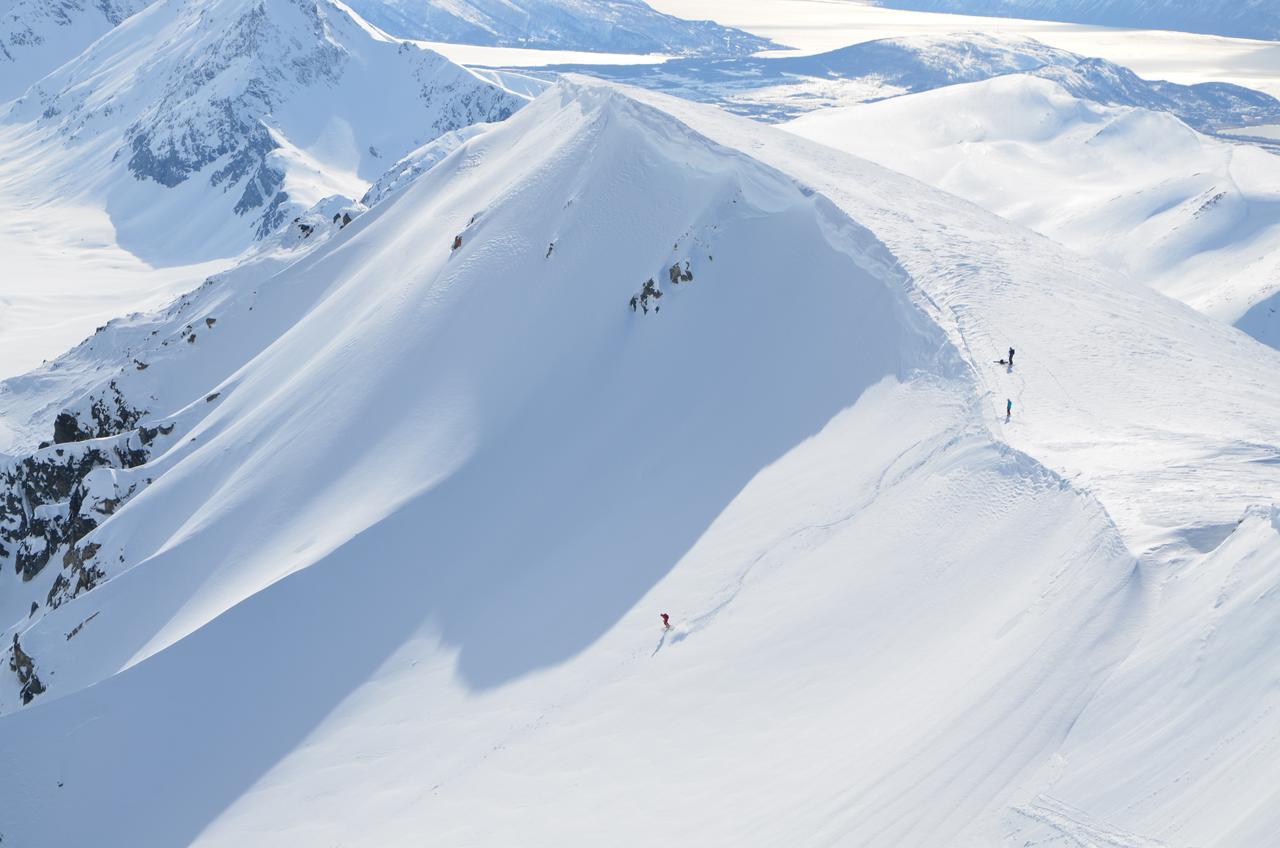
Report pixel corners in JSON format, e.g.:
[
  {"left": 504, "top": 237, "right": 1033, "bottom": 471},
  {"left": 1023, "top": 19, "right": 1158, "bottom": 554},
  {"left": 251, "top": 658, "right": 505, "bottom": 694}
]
[{"left": 637, "top": 86, "right": 1280, "bottom": 847}]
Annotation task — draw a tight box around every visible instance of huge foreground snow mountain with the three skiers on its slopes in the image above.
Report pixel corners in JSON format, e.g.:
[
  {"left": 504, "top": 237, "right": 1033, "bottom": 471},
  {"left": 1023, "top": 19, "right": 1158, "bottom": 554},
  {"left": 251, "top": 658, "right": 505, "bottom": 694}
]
[{"left": 0, "top": 79, "right": 1280, "bottom": 847}]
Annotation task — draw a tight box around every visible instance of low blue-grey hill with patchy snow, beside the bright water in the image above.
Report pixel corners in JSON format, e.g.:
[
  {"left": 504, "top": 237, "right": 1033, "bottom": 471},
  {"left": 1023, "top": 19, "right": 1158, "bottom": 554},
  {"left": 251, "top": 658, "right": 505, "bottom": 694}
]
[{"left": 540, "top": 32, "right": 1280, "bottom": 132}]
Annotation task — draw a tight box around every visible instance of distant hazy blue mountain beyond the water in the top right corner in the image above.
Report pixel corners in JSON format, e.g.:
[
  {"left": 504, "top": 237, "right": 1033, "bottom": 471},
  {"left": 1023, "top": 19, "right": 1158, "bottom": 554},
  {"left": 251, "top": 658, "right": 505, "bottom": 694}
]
[{"left": 876, "top": 0, "right": 1280, "bottom": 41}]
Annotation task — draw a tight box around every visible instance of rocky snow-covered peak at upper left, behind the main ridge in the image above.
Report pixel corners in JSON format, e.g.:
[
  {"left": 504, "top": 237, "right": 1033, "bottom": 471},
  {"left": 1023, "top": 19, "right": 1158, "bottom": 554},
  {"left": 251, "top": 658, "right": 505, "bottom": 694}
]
[{"left": 4, "top": 0, "right": 524, "bottom": 264}]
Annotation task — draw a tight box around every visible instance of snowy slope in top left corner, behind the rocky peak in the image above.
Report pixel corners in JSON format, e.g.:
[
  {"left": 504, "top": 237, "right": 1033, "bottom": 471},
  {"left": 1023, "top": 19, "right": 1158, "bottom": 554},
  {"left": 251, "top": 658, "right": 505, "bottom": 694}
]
[{"left": 0, "top": 0, "right": 151, "bottom": 102}]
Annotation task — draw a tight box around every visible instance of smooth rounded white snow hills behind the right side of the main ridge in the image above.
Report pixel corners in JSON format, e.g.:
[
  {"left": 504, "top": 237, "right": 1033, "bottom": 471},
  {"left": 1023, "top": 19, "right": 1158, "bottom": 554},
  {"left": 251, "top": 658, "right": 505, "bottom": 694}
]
[{"left": 787, "top": 76, "right": 1280, "bottom": 341}]
